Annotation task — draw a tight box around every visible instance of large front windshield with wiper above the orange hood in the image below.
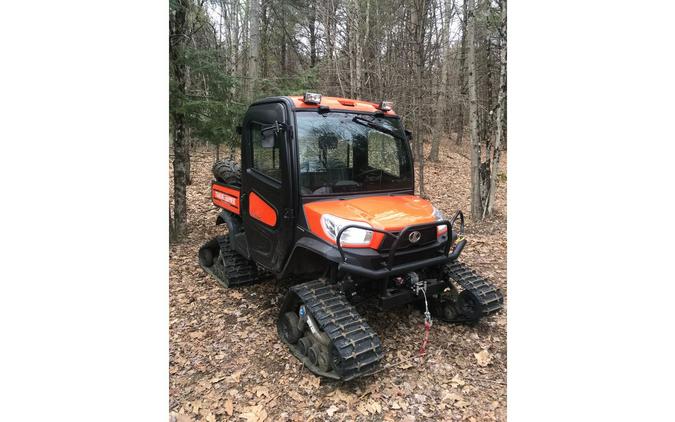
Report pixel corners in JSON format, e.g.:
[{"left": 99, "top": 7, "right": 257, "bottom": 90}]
[{"left": 296, "top": 112, "right": 412, "bottom": 195}]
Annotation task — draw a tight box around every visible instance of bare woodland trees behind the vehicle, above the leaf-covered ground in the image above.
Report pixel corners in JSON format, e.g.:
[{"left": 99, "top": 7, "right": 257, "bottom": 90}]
[{"left": 169, "top": 0, "right": 507, "bottom": 239}]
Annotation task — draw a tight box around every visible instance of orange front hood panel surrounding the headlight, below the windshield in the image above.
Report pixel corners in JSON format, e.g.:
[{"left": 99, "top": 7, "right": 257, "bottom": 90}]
[{"left": 304, "top": 195, "right": 436, "bottom": 249}]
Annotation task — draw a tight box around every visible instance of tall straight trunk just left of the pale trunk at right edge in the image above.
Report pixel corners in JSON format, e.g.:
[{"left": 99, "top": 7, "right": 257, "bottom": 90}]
[{"left": 466, "top": 0, "right": 483, "bottom": 220}]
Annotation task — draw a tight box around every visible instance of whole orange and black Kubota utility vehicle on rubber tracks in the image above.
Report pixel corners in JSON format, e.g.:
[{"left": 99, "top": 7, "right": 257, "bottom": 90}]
[{"left": 199, "top": 93, "right": 504, "bottom": 380}]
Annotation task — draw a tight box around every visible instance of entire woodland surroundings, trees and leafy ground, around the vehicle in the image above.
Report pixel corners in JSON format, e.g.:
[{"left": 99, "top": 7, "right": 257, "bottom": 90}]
[{"left": 169, "top": 0, "right": 507, "bottom": 421}]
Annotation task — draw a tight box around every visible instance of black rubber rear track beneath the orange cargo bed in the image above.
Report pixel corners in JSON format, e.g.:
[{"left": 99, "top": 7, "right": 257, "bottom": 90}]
[{"left": 205, "top": 236, "right": 269, "bottom": 288}]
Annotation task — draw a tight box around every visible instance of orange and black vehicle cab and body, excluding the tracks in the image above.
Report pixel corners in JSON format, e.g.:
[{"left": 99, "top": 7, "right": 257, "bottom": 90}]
[{"left": 213, "top": 94, "right": 460, "bottom": 286}]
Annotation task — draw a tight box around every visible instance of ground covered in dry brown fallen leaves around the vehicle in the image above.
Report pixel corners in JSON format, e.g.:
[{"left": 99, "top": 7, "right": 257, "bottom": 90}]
[{"left": 169, "top": 142, "right": 507, "bottom": 422}]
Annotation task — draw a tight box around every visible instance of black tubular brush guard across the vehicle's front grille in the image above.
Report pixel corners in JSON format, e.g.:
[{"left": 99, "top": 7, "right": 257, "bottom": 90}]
[{"left": 335, "top": 210, "right": 466, "bottom": 279}]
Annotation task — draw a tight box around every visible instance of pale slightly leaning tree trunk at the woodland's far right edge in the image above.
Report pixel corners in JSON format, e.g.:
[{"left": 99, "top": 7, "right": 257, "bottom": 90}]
[{"left": 487, "top": 0, "right": 506, "bottom": 216}]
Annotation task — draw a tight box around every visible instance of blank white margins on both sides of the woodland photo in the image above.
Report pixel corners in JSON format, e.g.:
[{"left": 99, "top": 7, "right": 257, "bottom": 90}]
[{"left": 0, "top": 1, "right": 675, "bottom": 421}]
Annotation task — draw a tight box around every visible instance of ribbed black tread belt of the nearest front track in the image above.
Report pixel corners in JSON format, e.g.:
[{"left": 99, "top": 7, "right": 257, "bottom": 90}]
[{"left": 291, "top": 281, "right": 384, "bottom": 381}]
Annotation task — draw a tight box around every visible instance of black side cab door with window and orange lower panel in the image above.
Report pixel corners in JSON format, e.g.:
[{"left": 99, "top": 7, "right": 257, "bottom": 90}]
[{"left": 241, "top": 102, "right": 294, "bottom": 272}]
